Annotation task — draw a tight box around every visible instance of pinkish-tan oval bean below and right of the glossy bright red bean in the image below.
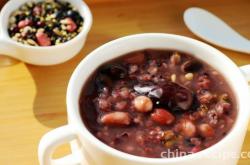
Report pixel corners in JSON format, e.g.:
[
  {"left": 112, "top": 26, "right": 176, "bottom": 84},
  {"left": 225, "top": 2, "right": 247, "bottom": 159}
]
[{"left": 181, "top": 119, "right": 196, "bottom": 138}]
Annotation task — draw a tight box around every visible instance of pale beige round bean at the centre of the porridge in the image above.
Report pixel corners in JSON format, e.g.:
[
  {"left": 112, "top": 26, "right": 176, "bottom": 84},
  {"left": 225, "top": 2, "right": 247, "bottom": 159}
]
[{"left": 134, "top": 96, "right": 153, "bottom": 112}]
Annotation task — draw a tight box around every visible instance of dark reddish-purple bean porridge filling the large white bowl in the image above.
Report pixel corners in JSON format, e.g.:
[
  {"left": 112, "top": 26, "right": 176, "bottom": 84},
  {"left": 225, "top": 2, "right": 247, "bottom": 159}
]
[{"left": 80, "top": 49, "right": 237, "bottom": 158}]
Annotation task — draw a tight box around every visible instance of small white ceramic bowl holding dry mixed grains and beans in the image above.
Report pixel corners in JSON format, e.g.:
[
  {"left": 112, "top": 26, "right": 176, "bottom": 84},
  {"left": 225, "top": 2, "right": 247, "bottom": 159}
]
[{"left": 0, "top": 0, "right": 92, "bottom": 65}]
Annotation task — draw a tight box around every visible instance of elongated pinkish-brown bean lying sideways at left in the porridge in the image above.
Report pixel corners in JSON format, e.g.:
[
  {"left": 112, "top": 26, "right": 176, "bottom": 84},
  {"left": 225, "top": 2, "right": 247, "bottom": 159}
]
[{"left": 100, "top": 112, "right": 131, "bottom": 126}]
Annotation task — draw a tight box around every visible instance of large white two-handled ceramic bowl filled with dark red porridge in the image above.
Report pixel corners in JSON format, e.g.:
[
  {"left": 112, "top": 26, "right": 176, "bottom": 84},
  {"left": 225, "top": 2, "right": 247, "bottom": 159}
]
[{"left": 39, "top": 33, "right": 250, "bottom": 165}]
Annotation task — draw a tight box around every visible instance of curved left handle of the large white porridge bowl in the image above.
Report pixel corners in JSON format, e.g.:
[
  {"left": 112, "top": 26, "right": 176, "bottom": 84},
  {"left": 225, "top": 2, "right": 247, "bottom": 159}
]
[{"left": 38, "top": 125, "right": 81, "bottom": 165}]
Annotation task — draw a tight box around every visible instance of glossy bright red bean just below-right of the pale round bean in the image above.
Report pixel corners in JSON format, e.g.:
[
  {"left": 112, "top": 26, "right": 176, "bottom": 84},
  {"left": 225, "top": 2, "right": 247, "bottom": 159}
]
[{"left": 151, "top": 109, "right": 175, "bottom": 125}]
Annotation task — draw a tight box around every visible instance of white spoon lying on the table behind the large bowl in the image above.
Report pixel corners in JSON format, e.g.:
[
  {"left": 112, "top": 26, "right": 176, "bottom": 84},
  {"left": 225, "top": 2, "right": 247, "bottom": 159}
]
[{"left": 184, "top": 7, "right": 250, "bottom": 54}]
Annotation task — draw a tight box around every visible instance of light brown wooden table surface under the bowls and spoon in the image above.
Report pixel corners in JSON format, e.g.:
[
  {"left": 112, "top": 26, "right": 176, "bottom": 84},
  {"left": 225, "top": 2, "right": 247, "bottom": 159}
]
[{"left": 0, "top": 0, "right": 250, "bottom": 165}]
